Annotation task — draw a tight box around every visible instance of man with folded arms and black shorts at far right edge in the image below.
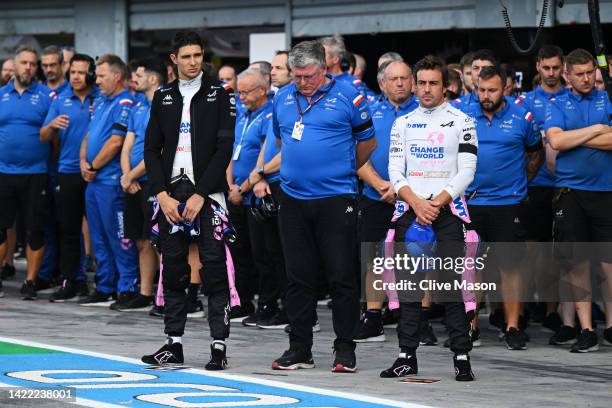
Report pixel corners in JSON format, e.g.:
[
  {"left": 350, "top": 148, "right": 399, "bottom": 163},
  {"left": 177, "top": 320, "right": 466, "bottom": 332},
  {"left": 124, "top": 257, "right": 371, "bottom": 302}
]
[{"left": 544, "top": 49, "right": 612, "bottom": 353}]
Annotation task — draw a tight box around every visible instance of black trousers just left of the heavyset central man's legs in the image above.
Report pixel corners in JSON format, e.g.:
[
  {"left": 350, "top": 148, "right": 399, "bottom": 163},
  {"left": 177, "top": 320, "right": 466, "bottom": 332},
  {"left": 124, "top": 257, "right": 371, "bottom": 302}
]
[{"left": 248, "top": 181, "right": 287, "bottom": 307}]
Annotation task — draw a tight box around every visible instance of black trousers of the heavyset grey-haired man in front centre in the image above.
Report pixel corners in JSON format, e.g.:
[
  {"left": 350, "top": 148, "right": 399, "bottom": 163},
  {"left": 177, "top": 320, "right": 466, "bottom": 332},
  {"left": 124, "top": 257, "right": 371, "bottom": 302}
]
[{"left": 279, "top": 194, "right": 359, "bottom": 350}]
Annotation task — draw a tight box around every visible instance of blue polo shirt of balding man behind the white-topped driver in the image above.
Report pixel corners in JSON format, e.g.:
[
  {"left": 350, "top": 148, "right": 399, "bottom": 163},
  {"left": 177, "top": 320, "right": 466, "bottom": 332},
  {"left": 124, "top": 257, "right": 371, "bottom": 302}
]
[{"left": 363, "top": 96, "right": 419, "bottom": 200}]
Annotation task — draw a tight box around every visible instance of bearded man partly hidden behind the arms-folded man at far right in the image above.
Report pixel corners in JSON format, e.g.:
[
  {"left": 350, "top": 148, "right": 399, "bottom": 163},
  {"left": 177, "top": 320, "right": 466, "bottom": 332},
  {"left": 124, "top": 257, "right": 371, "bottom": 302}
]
[{"left": 518, "top": 45, "right": 576, "bottom": 344}]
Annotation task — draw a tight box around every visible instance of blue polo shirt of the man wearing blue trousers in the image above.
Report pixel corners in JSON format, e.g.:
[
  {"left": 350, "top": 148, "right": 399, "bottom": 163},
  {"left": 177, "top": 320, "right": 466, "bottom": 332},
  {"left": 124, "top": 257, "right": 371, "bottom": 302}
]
[{"left": 87, "top": 88, "right": 134, "bottom": 186}]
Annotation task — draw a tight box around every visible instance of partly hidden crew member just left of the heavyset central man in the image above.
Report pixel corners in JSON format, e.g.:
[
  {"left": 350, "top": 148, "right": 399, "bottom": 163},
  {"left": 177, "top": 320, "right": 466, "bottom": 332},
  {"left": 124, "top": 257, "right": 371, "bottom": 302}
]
[{"left": 249, "top": 51, "right": 294, "bottom": 329}]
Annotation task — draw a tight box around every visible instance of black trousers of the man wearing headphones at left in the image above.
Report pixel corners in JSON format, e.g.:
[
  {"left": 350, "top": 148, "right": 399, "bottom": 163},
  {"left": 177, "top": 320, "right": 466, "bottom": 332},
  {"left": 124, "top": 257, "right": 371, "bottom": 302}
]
[{"left": 58, "top": 173, "right": 87, "bottom": 282}]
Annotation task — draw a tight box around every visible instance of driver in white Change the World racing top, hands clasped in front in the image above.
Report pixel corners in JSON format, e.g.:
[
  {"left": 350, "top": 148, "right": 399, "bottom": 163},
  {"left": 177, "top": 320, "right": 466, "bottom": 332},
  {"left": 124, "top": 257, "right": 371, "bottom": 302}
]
[{"left": 380, "top": 56, "right": 478, "bottom": 381}]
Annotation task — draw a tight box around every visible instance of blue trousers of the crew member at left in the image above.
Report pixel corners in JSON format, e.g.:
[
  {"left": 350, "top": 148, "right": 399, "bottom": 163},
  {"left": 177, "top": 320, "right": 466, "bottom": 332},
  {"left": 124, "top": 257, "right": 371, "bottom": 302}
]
[{"left": 85, "top": 181, "right": 139, "bottom": 293}]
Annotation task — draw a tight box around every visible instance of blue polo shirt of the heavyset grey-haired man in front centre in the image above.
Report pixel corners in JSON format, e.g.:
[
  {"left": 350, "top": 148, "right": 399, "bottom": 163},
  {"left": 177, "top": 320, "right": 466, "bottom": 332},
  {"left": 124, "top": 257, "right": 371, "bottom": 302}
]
[{"left": 273, "top": 75, "right": 374, "bottom": 200}]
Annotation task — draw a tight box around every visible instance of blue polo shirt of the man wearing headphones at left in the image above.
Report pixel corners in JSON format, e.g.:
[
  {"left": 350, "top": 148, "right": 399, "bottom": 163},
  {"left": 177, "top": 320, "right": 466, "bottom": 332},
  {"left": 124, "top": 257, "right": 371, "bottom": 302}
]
[{"left": 43, "top": 87, "right": 99, "bottom": 174}]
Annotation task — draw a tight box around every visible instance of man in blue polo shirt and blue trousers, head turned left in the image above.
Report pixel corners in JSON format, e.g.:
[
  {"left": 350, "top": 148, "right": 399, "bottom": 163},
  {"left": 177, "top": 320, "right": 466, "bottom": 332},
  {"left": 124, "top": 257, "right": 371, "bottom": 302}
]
[{"left": 80, "top": 54, "right": 138, "bottom": 305}]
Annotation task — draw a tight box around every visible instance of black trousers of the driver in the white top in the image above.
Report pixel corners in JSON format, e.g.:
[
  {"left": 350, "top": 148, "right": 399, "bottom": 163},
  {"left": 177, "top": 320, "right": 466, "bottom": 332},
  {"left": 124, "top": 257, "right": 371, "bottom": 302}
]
[{"left": 395, "top": 209, "right": 472, "bottom": 353}]
